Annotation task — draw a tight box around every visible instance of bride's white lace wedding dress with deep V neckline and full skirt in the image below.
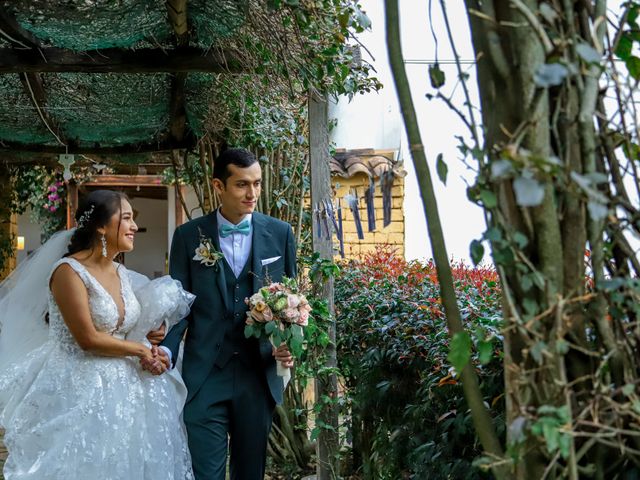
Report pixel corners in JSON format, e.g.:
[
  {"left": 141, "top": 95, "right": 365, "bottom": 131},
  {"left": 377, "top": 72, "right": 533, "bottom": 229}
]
[{"left": 0, "top": 258, "right": 193, "bottom": 480}]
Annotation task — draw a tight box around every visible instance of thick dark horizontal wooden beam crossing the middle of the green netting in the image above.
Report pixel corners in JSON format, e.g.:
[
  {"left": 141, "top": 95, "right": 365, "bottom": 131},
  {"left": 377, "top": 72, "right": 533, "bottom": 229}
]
[{"left": 0, "top": 46, "right": 243, "bottom": 73}]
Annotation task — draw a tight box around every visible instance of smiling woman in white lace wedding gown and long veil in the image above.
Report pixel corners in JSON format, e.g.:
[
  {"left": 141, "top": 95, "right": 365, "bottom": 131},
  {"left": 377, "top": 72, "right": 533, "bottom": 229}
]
[{"left": 0, "top": 190, "right": 193, "bottom": 480}]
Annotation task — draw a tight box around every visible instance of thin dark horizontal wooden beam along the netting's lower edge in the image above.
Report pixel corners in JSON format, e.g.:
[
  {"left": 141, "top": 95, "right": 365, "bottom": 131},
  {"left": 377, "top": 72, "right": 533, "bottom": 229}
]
[{"left": 0, "top": 136, "right": 195, "bottom": 154}]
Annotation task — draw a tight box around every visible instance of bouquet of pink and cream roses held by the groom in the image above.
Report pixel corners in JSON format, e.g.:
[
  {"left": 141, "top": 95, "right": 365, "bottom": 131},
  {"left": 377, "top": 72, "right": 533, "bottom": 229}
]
[{"left": 244, "top": 277, "right": 311, "bottom": 384}]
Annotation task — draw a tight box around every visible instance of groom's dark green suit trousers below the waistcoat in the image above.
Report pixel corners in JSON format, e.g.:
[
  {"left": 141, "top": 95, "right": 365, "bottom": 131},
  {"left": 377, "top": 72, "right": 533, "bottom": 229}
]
[{"left": 184, "top": 356, "right": 275, "bottom": 480}]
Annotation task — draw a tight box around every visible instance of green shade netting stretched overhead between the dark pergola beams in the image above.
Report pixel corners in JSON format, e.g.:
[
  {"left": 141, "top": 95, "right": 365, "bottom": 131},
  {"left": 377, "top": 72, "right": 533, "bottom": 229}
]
[{"left": 0, "top": 0, "right": 249, "bottom": 147}]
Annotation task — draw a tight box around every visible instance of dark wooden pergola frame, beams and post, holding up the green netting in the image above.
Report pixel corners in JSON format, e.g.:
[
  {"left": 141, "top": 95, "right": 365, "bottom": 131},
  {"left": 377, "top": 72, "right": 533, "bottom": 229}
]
[{"left": 0, "top": 0, "right": 337, "bottom": 480}]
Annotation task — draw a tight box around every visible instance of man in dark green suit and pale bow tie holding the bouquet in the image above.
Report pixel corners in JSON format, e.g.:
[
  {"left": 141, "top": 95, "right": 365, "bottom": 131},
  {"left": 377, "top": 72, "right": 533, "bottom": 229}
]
[{"left": 160, "top": 149, "right": 296, "bottom": 480}]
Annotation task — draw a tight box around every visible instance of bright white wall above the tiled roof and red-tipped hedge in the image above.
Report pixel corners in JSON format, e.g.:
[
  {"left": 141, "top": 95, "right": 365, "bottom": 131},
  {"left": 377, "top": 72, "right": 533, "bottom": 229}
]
[{"left": 329, "top": 0, "right": 485, "bottom": 260}]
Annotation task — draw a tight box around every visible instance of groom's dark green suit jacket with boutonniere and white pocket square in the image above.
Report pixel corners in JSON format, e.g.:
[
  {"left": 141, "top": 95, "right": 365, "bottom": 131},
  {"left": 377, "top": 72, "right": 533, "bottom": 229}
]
[{"left": 162, "top": 212, "right": 296, "bottom": 403}]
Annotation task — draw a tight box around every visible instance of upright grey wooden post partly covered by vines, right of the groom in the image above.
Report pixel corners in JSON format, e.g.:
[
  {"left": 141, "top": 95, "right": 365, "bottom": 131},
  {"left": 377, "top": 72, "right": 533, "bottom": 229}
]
[{"left": 309, "top": 93, "right": 339, "bottom": 480}]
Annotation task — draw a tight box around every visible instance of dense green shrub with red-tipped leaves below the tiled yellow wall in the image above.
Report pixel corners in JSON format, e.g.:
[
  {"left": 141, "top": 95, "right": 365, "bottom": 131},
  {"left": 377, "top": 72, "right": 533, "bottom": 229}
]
[{"left": 336, "top": 247, "right": 504, "bottom": 480}]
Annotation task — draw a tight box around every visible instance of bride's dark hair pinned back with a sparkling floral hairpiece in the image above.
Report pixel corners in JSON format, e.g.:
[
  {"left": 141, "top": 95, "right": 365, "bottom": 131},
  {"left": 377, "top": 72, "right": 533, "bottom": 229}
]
[{"left": 65, "top": 190, "right": 129, "bottom": 257}]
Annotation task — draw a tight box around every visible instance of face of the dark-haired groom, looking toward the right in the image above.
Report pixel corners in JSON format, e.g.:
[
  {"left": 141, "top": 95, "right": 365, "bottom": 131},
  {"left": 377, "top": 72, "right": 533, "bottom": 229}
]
[{"left": 213, "top": 162, "right": 262, "bottom": 221}]
